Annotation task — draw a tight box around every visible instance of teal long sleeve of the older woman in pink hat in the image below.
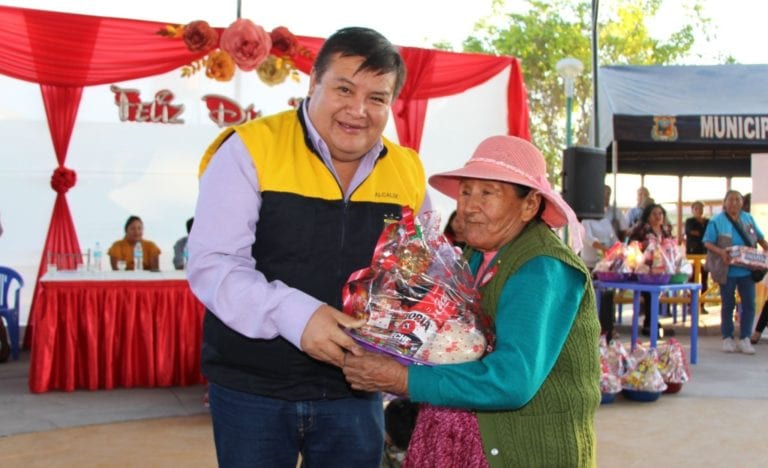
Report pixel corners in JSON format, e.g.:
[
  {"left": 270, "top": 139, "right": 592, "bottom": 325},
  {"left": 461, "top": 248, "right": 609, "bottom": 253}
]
[{"left": 408, "top": 256, "right": 584, "bottom": 411}]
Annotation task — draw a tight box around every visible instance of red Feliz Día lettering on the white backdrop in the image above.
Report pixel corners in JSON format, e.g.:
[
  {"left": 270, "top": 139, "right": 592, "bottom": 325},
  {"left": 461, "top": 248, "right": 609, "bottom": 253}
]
[{"left": 110, "top": 85, "right": 301, "bottom": 127}]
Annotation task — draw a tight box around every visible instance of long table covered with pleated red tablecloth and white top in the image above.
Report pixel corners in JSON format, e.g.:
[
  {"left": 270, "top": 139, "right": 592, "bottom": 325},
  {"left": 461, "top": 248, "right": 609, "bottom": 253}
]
[{"left": 29, "top": 271, "right": 204, "bottom": 393}]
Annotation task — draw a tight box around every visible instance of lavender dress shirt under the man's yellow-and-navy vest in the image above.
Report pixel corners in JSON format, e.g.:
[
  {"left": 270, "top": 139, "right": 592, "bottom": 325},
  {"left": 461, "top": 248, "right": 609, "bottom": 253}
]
[{"left": 187, "top": 101, "right": 431, "bottom": 349}]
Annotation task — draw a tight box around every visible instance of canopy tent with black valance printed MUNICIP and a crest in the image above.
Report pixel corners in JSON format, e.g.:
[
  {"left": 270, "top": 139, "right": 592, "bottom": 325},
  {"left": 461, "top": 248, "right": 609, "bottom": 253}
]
[{"left": 596, "top": 65, "right": 768, "bottom": 238}]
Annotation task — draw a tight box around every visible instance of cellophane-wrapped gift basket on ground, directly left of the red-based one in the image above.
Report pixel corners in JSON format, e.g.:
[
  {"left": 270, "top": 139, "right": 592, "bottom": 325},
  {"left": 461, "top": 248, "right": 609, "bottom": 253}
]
[{"left": 622, "top": 346, "right": 667, "bottom": 401}]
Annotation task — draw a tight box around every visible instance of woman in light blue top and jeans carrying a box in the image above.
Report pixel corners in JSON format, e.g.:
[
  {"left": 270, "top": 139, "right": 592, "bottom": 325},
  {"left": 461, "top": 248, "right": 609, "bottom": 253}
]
[{"left": 703, "top": 190, "right": 768, "bottom": 354}]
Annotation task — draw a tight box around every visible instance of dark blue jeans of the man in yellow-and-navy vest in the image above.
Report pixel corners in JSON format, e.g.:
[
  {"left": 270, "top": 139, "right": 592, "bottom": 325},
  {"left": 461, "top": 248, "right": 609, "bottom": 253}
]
[{"left": 208, "top": 383, "right": 384, "bottom": 468}]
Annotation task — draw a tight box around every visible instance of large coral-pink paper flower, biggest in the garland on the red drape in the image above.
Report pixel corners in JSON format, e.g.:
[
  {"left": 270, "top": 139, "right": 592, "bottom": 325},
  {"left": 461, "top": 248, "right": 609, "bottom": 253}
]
[{"left": 221, "top": 18, "right": 272, "bottom": 71}]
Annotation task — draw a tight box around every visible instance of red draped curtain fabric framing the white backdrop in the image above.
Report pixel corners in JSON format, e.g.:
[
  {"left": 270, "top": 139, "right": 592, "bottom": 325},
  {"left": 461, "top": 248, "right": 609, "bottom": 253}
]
[{"left": 0, "top": 6, "right": 530, "bottom": 342}]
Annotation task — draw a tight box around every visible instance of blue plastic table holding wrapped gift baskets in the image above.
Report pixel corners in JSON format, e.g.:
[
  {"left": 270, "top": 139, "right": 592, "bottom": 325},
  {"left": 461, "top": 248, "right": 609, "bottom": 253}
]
[{"left": 594, "top": 281, "right": 701, "bottom": 364}]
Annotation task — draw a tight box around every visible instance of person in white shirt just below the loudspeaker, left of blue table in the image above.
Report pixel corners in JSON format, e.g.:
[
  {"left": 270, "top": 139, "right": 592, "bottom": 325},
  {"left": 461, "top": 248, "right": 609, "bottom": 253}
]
[{"left": 581, "top": 185, "right": 627, "bottom": 341}]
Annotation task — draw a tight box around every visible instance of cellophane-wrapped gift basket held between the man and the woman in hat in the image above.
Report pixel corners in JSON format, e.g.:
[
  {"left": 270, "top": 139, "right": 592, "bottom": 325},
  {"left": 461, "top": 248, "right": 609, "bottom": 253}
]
[{"left": 342, "top": 207, "right": 493, "bottom": 364}]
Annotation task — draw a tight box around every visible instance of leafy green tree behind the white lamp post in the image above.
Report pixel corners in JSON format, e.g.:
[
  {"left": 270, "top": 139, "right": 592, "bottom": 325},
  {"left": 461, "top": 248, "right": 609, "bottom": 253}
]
[{"left": 460, "top": 0, "right": 709, "bottom": 181}]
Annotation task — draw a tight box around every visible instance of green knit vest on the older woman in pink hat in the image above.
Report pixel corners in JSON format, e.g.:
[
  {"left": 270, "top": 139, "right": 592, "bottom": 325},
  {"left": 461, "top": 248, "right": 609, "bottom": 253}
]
[{"left": 477, "top": 221, "right": 600, "bottom": 468}]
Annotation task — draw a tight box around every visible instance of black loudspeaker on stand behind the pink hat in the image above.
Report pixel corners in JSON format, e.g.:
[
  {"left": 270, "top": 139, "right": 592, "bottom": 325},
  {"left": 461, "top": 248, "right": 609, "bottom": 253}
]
[{"left": 563, "top": 146, "right": 607, "bottom": 219}]
